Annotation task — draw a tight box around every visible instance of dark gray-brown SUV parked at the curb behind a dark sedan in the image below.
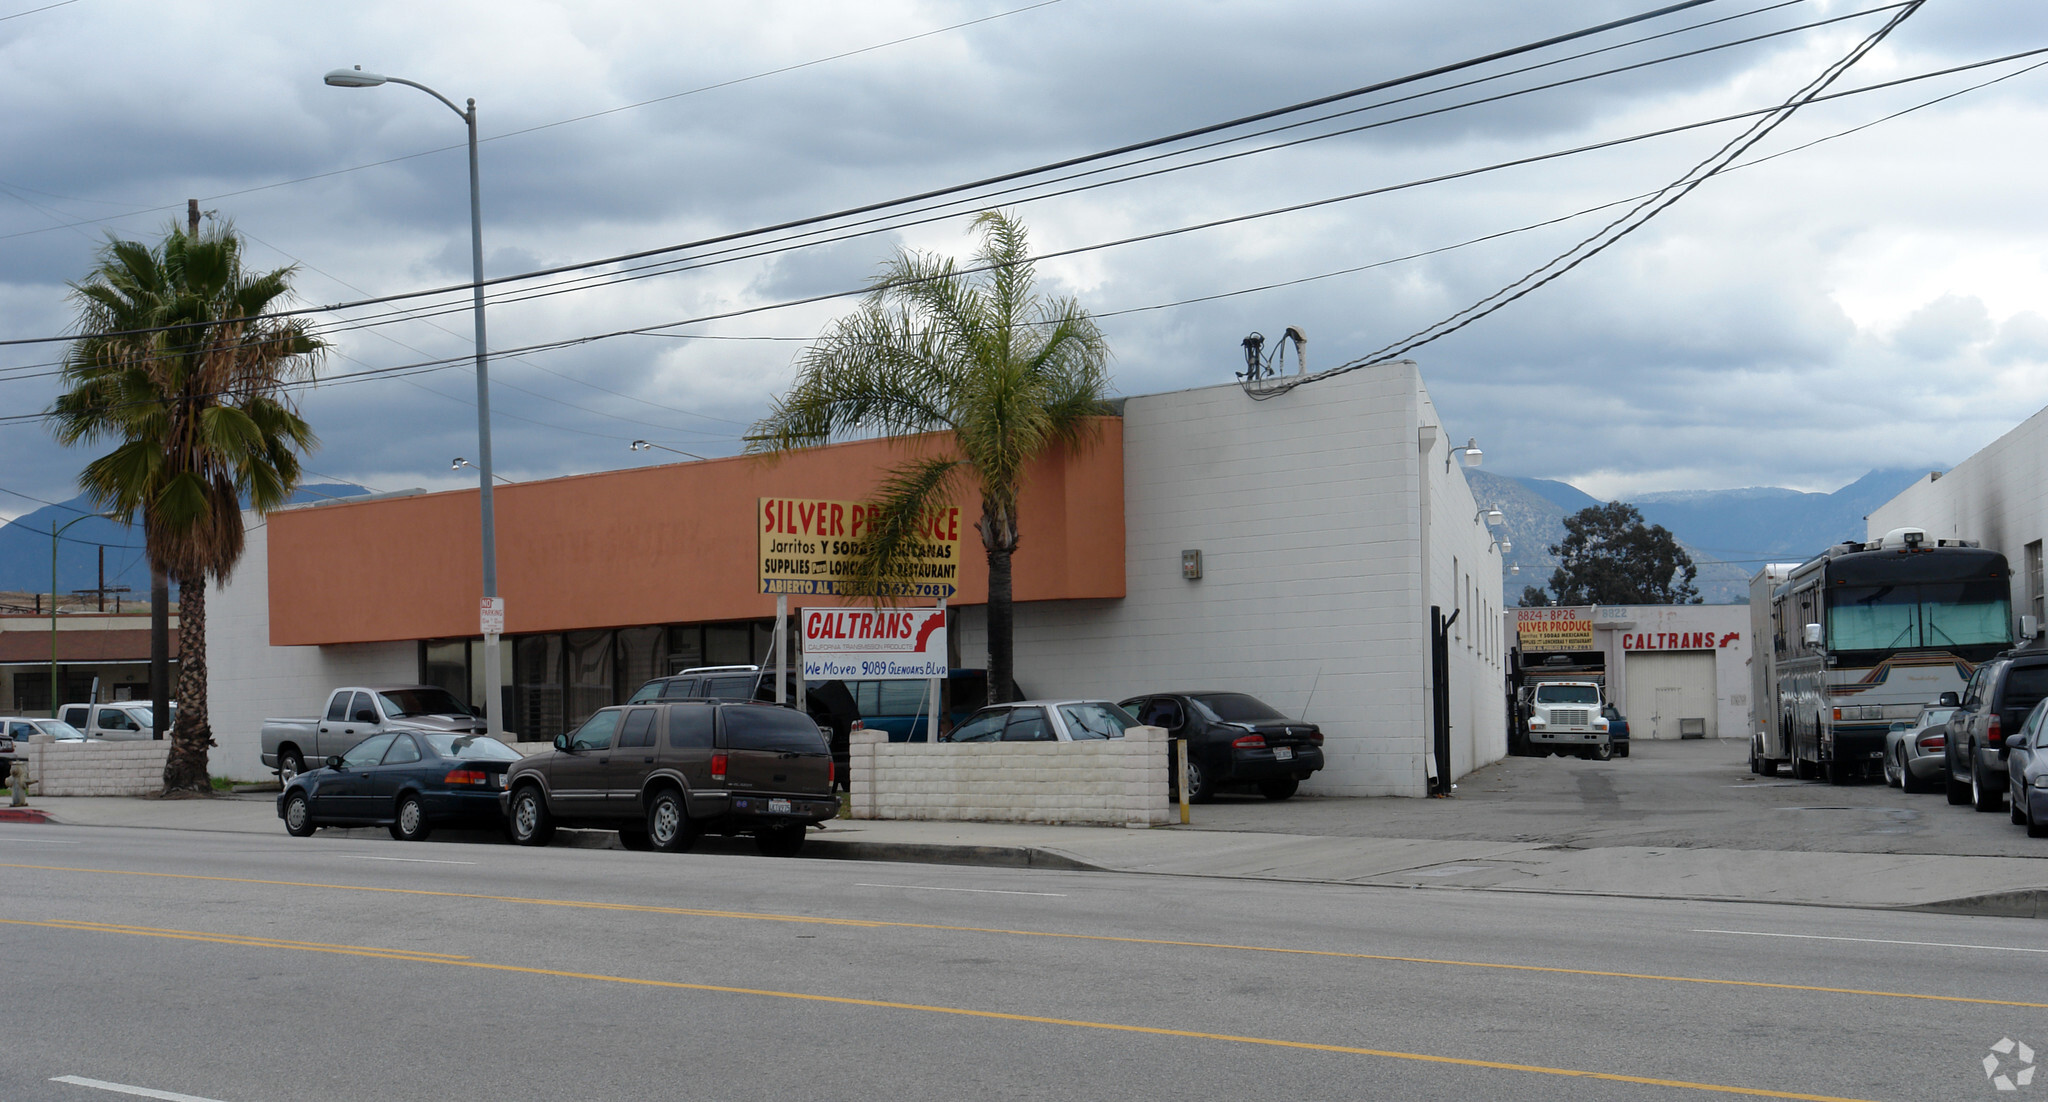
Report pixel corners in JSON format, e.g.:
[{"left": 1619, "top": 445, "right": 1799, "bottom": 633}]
[{"left": 498, "top": 701, "right": 840, "bottom": 856}]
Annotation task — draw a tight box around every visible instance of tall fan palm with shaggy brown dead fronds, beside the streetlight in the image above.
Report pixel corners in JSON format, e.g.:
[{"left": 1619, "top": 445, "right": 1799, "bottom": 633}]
[{"left": 47, "top": 225, "right": 324, "bottom": 793}]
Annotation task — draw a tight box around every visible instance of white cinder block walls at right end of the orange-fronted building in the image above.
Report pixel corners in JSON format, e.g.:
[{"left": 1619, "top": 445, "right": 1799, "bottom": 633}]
[{"left": 1003, "top": 363, "right": 1505, "bottom": 795}]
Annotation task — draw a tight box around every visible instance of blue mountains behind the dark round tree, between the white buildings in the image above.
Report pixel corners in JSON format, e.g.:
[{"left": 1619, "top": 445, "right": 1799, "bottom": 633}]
[{"left": 1464, "top": 467, "right": 1927, "bottom": 606}]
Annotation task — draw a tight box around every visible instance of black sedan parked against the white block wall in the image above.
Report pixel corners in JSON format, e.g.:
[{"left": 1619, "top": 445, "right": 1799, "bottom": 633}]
[{"left": 1122, "top": 692, "right": 1323, "bottom": 803}]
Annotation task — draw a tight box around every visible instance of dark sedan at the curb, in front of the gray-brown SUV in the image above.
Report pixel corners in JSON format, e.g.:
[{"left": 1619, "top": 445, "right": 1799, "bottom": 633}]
[{"left": 276, "top": 731, "right": 520, "bottom": 842}]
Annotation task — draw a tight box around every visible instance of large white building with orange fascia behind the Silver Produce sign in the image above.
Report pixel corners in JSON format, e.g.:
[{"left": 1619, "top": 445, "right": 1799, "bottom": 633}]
[{"left": 209, "top": 361, "right": 1505, "bottom": 795}]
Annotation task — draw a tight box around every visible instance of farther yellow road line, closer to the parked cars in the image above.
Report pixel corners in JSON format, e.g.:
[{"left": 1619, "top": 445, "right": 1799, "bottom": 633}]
[{"left": 0, "top": 862, "right": 2048, "bottom": 1010}]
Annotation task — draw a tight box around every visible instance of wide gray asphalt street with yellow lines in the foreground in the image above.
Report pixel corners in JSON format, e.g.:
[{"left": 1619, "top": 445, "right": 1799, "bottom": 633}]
[{"left": 0, "top": 819, "right": 2048, "bottom": 1102}]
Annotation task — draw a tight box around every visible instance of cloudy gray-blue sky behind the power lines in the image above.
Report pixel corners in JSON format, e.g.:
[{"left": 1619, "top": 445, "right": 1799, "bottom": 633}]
[{"left": 0, "top": 0, "right": 2048, "bottom": 516}]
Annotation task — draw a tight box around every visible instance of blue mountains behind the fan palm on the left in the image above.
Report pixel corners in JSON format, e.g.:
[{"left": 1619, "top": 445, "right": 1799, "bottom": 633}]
[{"left": 0, "top": 483, "right": 369, "bottom": 608}]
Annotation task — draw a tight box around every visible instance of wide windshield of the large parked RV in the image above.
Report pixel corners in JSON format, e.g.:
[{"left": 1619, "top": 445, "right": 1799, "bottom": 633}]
[{"left": 1827, "top": 582, "right": 2011, "bottom": 651}]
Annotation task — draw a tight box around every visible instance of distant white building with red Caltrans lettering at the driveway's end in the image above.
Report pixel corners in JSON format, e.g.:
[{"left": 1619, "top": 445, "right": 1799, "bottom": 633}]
[{"left": 1505, "top": 604, "right": 1751, "bottom": 739}]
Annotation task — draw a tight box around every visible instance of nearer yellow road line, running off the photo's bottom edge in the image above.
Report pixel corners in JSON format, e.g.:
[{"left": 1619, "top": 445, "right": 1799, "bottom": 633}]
[{"left": 0, "top": 918, "right": 1870, "bottom": 1102}]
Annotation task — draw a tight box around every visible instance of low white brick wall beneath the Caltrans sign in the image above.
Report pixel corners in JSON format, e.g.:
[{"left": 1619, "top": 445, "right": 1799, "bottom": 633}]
[{"left": 850, "top": 727, "right": 1169, "bottom": 828}]
